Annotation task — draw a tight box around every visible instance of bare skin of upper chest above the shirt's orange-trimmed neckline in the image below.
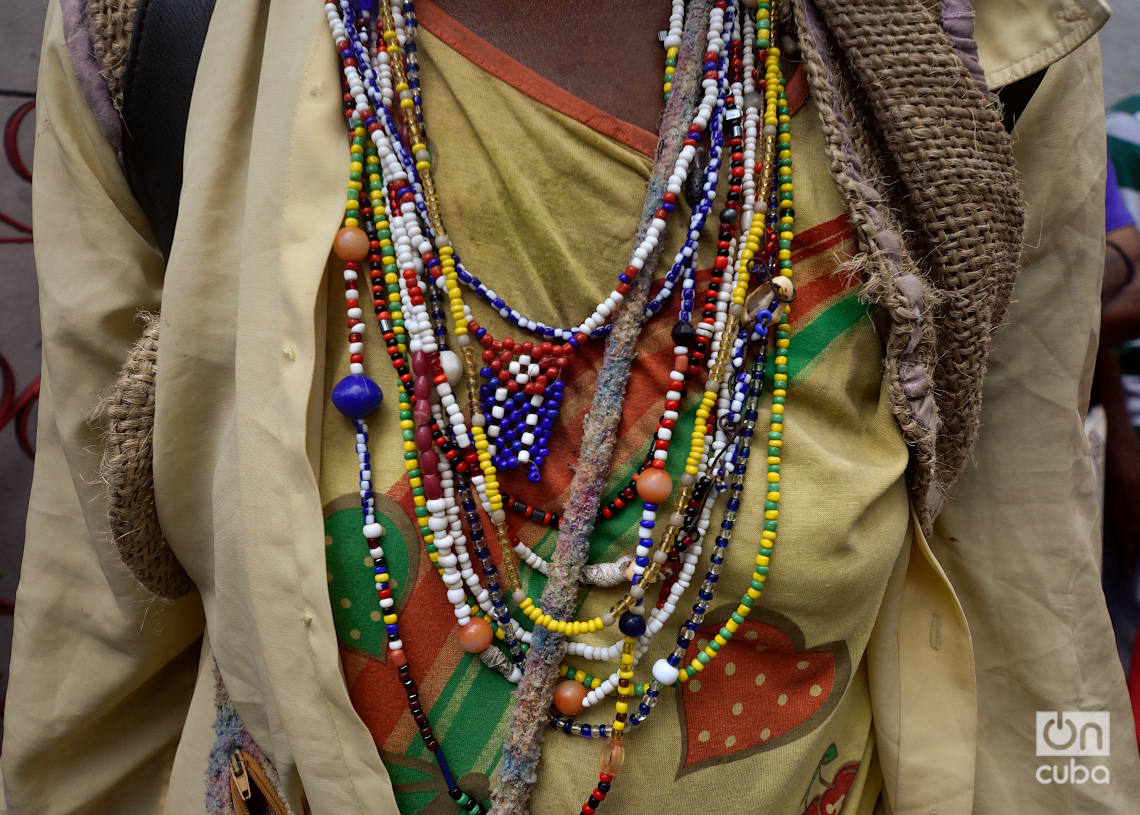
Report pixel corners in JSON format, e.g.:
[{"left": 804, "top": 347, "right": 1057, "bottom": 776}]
[{"left": 437, "top": 0, "right": 669, "bottom": 133}]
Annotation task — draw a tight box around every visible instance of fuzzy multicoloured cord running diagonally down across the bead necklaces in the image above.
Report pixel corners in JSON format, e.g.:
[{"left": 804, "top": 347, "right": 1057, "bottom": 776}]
[{"left": 491, "top": 0, "right": 710, "bottom": 815}]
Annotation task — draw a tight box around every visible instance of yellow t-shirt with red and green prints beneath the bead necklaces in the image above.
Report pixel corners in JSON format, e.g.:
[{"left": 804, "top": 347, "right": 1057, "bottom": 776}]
[{"left": 320, "top": 7, "right": 909, "bottom": 815}]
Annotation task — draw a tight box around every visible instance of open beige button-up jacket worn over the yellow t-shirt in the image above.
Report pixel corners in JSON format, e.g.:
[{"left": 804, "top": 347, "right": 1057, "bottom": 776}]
[{"left": 2, "top": 0, "right": 1140, "bottom": 815}]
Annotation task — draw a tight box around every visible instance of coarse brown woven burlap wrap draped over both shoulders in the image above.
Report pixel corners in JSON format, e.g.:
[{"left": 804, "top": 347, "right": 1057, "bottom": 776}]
[{"left": 87, "top": 0, "right": 1023, "bottom": 597}]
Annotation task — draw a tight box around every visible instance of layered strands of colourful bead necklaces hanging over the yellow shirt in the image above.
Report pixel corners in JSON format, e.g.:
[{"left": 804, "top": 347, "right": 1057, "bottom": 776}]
[{"left": 324, "top": 0, "right": 795, "bottom": 815}]
